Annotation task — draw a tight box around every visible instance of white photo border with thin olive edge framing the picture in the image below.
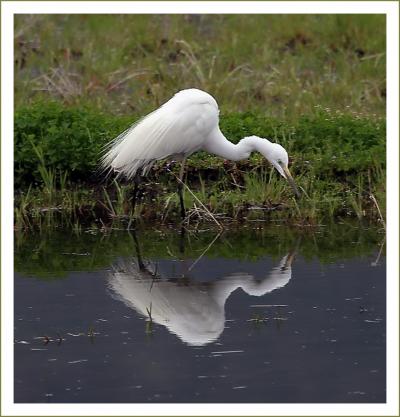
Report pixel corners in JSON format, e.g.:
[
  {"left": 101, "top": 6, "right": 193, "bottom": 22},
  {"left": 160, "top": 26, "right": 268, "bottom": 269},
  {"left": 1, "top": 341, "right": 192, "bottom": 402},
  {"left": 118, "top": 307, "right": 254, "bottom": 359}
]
[{"left": 1, "top": 1, "right": 399, "bottom": 416}]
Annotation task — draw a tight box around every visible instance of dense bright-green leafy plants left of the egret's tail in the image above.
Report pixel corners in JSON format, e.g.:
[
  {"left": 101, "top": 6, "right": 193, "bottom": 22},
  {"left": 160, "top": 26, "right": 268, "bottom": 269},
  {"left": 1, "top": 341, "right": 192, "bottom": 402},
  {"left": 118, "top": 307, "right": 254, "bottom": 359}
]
[{"left": 14, "top": 101, "right": 130, "bottom": 186}]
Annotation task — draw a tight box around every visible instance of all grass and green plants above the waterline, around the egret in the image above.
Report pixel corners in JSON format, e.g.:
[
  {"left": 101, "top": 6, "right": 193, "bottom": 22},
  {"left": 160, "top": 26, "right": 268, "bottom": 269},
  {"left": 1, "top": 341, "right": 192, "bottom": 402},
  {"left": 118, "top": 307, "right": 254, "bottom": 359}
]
[{"left": 14, "top": 15, "right": 386, "bottom": 230}]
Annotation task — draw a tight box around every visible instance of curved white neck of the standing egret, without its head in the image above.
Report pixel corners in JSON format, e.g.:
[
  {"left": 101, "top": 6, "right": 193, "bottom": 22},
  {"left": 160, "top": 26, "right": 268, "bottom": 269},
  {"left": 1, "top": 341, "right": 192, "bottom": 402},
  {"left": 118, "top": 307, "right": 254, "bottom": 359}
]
[{"left": 204, "top": 129, "right": 272, "bottom": 161}]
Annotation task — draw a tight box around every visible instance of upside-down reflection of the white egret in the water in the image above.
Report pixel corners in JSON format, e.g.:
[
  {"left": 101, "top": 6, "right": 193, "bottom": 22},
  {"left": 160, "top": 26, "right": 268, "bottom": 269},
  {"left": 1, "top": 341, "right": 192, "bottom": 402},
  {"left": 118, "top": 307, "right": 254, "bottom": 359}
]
[{"left": 108, "top": 231, "right": 296, "bottom": 346}]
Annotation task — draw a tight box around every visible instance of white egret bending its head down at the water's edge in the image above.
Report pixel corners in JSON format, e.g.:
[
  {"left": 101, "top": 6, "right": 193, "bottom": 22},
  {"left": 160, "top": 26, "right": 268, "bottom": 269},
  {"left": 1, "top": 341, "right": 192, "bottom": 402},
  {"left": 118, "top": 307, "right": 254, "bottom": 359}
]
[{"left": 102, "top": 88, "right": 300, "bottom": 217}]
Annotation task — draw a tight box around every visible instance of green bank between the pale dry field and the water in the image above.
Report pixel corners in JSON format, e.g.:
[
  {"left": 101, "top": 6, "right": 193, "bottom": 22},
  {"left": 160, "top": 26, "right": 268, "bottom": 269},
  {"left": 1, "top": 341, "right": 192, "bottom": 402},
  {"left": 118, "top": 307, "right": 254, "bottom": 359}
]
[{"left": 15, "top": 102, "right": 385, "bottom": 228}]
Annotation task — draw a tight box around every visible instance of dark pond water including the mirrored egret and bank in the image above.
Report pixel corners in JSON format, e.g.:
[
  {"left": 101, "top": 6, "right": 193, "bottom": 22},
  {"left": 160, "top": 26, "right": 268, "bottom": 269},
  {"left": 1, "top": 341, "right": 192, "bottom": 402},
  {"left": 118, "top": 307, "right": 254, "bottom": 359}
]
[{"left": 15, "top": 228, "right": 386, "bottom": 403}]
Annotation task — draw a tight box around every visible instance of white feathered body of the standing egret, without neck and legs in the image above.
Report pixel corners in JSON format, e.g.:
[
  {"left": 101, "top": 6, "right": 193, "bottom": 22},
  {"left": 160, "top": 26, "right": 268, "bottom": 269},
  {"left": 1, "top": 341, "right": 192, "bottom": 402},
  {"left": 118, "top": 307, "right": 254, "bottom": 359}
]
[{"left": 103, "top": 89, "right": 219, "bottom": 178}]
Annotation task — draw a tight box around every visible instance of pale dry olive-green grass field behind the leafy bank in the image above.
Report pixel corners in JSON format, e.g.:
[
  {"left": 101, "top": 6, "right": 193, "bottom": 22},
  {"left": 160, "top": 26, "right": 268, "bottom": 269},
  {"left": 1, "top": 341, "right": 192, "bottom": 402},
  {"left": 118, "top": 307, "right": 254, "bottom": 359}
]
[{"left": 15, "top": 15, "right": 386, "bottom": 119}]
